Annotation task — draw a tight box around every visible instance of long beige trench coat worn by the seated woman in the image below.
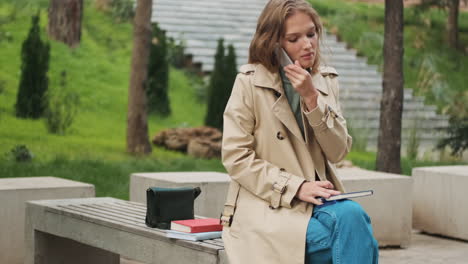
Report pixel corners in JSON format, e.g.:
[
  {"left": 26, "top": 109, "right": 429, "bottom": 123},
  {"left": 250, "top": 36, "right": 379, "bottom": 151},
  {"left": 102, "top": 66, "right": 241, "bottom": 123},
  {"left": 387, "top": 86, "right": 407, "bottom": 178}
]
[{"left": 222, "top": 64, "right": 351, "bottom": 264}]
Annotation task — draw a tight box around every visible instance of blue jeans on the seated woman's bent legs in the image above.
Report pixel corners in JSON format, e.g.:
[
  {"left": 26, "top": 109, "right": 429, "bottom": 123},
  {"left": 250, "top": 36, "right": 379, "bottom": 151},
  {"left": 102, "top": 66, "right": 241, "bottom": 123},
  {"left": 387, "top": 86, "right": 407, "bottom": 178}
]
[{"left": 305, "top": 200, "right": 379, "bottom": 264}]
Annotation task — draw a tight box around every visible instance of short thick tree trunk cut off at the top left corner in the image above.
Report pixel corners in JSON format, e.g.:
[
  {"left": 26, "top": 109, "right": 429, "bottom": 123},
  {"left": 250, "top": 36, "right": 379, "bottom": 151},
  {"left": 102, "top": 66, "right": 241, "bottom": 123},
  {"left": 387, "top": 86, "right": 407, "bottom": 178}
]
[{"left": 47, "top": 0, "right": 83, "bottom": 48}]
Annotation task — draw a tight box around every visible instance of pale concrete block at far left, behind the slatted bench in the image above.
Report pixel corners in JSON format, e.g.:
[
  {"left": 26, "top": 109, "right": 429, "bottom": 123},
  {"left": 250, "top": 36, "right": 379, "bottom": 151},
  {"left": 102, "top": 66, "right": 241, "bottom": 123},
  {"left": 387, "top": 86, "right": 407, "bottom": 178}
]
[{"left": 0, "top": 177, "right": 95, "bottom": 264}]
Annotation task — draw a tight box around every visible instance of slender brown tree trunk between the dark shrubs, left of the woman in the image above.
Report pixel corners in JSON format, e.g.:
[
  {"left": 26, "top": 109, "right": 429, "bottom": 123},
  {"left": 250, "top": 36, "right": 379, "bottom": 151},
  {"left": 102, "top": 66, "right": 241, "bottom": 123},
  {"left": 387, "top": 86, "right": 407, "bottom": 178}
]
[{"left": 127, "top": 0, "right": 152, "bottom": 154}]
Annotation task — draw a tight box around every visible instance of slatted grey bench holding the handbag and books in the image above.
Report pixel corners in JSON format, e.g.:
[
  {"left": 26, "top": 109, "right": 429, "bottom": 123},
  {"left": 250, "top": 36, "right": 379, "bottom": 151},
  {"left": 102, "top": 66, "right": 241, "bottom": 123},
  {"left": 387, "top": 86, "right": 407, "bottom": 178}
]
[{"left": 25, "top": 198, "right": 227, "bottom": 264}]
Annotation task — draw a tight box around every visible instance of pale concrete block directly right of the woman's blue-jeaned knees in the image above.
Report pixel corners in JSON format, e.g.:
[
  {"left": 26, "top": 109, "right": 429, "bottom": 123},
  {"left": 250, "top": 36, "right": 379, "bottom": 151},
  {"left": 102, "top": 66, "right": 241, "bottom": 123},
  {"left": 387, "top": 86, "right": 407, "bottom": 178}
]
[{"left": 338, "top": 168, "right": 413, "bottom": 248}]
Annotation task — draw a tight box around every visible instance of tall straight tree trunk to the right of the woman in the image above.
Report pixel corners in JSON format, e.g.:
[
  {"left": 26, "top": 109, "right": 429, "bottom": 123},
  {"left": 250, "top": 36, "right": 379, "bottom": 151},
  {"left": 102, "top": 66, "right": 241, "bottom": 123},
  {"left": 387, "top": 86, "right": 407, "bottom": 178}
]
[{"left": 376, "top": 0, "right": 403, "bottom": 174}]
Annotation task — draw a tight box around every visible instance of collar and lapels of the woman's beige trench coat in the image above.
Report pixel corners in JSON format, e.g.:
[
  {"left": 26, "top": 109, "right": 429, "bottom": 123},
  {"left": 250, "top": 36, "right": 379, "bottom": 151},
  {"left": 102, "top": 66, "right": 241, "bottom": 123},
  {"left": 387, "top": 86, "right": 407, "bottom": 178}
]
[{"left": 254, "top": 64, "right": 328, "bottom": 143}]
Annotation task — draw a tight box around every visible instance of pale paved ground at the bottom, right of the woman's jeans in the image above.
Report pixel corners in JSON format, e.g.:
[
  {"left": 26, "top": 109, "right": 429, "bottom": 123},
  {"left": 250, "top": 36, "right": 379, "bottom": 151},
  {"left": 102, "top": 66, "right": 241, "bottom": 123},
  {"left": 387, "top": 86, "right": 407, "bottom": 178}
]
[{"left": 120, "top": 231, "right": 468, "bottom": 264}]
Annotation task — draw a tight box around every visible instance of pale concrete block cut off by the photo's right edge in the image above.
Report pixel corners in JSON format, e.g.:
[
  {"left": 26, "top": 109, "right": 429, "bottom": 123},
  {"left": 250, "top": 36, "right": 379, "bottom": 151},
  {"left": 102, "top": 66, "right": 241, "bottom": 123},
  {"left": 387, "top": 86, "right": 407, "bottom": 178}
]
[{"left": 412, "top": 166, "right": 468, "bottom": 240}]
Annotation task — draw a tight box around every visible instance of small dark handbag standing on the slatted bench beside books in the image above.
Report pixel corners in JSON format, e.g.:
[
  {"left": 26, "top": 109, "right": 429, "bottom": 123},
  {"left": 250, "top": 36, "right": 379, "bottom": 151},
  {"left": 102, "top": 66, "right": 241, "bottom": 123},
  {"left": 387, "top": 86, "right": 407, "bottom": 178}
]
[{"left": 145, "top": 187, "right": 201, "bottom": 229}]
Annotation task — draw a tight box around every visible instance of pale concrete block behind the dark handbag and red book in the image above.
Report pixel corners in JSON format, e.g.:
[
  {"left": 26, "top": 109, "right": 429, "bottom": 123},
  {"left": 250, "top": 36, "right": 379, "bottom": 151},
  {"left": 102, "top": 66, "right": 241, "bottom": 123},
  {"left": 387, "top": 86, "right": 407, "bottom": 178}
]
[{"left": 130, "top": 172, "right": 231, "bottom": 218}]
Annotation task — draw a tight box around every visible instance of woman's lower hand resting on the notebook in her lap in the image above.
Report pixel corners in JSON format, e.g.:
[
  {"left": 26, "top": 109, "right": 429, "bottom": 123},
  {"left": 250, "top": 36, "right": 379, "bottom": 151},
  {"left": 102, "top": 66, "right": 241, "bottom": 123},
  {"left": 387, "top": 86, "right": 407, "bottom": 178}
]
[{"left": 296, "top": 181, "right": 341, "bottom": 205}]
